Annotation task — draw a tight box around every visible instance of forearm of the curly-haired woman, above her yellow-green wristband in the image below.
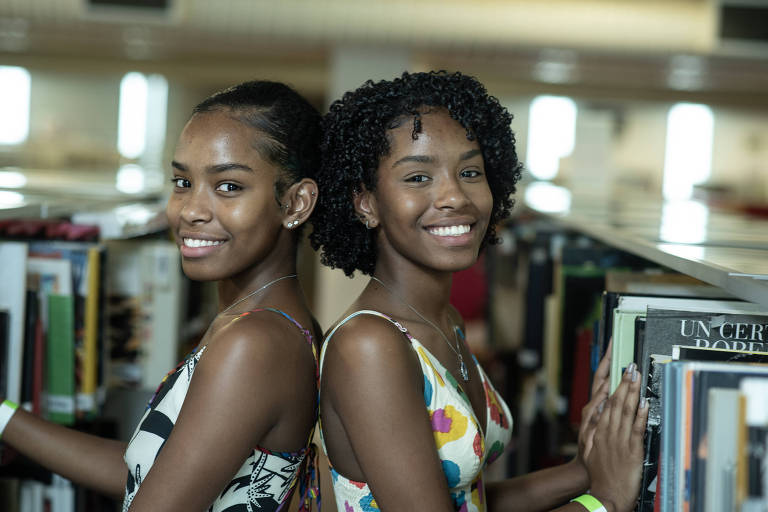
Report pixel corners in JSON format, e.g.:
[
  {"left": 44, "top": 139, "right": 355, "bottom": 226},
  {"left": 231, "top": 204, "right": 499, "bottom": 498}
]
[{"left": 486, "top": 460, "right": 589, "bottom": 512}]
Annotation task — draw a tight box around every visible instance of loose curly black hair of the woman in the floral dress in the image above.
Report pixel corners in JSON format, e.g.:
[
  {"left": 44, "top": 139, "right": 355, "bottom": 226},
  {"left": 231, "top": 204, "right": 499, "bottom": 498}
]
[{"left": 310, "top": 71, "right": 523, "bottom": 276}]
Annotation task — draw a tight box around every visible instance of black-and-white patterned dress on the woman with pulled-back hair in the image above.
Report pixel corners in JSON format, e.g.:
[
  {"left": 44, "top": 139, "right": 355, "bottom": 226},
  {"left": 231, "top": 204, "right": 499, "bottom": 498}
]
[{"left": 123, "top": 308, "right": 319, "bottom": 512}]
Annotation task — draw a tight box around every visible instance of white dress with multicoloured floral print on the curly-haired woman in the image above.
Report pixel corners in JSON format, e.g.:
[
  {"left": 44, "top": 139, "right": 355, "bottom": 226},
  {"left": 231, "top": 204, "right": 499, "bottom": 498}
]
[{"left": 320, "top": 310, "right": 512, "bottom": 512}]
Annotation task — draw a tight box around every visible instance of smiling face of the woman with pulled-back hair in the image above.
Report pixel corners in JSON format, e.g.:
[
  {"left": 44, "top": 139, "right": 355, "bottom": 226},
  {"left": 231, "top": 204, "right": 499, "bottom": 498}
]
[{"left": 166, "top": 110, "right": 282, "bottom": 281}]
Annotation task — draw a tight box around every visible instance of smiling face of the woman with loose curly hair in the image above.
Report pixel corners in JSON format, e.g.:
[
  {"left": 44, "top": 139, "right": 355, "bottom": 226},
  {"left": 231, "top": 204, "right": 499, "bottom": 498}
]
[{"left": 362, "top": 109, "right": 493, "bottom": 271}]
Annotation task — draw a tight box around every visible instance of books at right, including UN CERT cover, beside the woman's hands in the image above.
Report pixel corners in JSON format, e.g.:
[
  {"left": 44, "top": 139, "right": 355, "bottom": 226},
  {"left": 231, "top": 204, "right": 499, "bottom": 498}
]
[{"left": 596, "top": 285, "right": 768, "bottom": 512}]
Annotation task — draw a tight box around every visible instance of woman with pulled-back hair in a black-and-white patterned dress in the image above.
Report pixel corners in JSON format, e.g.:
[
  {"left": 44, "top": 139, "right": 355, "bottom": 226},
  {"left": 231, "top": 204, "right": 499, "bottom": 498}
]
[{"left": 2, "top": 82, "right": 320, "bottom": 512}]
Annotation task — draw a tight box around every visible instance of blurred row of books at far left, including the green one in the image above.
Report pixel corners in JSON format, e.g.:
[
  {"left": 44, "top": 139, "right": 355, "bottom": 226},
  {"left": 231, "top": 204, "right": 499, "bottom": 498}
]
[{"left": 0, "top": 231, "right": 105, "bottom": 425}]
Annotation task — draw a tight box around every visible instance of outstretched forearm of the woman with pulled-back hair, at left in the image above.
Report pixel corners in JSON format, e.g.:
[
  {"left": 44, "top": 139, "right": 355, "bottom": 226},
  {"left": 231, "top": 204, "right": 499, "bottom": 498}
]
[{"left": 3, "top": 408, "right": 127, "bottom": 497}]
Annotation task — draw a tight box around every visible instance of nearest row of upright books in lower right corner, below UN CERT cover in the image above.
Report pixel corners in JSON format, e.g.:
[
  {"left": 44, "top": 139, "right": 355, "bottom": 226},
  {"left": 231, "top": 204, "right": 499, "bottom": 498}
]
[{"left": 656, "top": 361, "right": 768, "bottom": 512}]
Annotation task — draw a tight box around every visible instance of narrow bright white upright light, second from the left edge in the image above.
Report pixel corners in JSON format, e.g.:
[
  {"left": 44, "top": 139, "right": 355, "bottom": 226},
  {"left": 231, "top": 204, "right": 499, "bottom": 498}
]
[{"left": 117, "top": 72, "right": 149, "bottom": 158}]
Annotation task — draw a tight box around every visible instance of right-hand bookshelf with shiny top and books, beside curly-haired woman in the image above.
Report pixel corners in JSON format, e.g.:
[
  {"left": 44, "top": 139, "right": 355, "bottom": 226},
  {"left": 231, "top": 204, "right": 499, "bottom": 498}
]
[{"left": 510, "top": 184, "right": 768, "bottom": 512}]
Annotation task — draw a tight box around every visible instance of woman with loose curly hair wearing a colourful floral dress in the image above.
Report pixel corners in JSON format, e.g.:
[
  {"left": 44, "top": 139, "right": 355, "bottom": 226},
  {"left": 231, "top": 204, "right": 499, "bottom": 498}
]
[{"left": 311, "top": 72, "right": 647, "bottom": 512}]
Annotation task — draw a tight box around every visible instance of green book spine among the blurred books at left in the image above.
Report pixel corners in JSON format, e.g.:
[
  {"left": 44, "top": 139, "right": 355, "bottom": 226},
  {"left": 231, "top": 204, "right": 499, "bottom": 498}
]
[{"left": 46, "top": 294, "right": 75, "bottom": 425}]
